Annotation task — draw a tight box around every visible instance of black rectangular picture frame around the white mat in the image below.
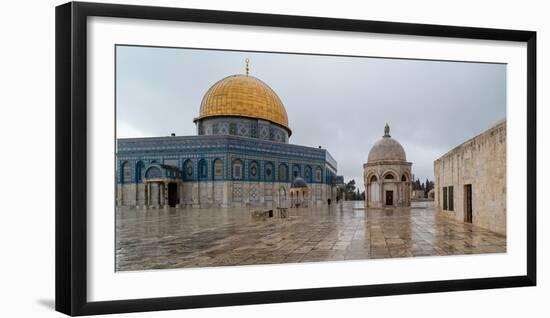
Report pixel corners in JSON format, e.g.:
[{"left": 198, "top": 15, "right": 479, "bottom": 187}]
[{"left": 55, "top": 2, "right": 536, "bottom": 315}]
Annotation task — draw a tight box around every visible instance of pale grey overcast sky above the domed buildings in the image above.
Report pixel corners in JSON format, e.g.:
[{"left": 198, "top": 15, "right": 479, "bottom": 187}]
[{"left": 116, "top": 46, "right": 506, "bottom": 189}]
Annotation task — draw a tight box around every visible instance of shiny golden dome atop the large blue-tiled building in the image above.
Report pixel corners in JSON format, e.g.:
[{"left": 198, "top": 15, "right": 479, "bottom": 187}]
[{"left": 195, "top": 75, "right": 290, "bottom": 134}]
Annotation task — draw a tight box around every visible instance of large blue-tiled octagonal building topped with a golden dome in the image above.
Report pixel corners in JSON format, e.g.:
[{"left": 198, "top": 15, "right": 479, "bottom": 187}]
[{"left": 116, "top": 60, "right": 343, "bottom": 207}]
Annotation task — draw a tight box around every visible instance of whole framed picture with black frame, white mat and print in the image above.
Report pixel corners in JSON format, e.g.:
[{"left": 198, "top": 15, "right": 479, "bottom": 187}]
[{"left": 56, "top": 2, "right": 536, "bottom": 315}]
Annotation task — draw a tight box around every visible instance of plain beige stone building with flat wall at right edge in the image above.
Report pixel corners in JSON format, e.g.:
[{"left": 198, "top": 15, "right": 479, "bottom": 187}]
[{"left": 434, "top": 121, "right": 506, "bottom": 235}]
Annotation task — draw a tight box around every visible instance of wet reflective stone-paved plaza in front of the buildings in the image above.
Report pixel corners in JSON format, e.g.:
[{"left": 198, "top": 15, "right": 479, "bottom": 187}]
[{"left": 116, "top": 201, "right": 506, "bottom": 271}]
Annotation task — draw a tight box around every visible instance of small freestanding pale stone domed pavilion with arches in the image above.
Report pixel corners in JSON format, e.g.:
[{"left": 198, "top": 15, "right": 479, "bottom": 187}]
[{"left": 363, "top": 124, "right": 412, "bottom": 208}]
